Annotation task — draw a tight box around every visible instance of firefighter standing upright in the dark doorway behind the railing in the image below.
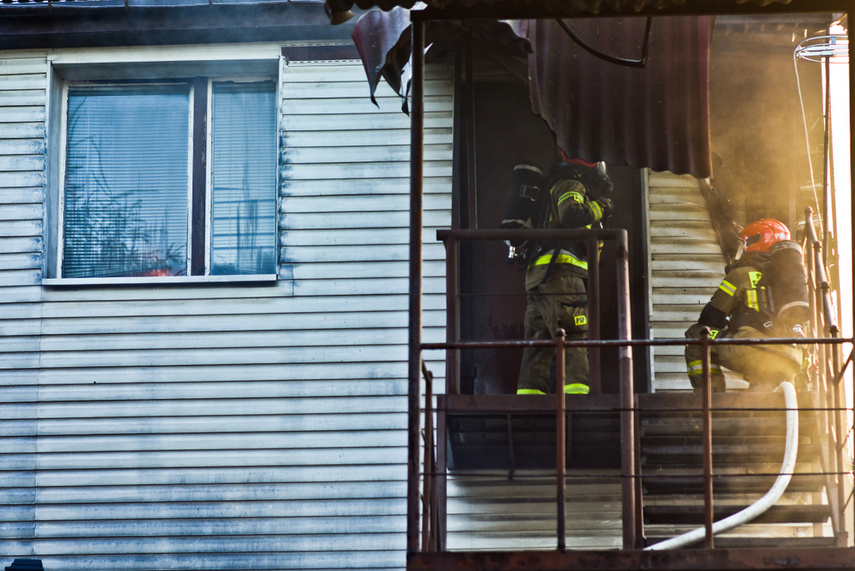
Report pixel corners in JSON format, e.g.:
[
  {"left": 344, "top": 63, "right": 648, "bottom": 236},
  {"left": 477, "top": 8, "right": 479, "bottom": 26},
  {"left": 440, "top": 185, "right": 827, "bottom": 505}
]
[{"left": 503, "top": 153, "right": 612, "bottom": 394}]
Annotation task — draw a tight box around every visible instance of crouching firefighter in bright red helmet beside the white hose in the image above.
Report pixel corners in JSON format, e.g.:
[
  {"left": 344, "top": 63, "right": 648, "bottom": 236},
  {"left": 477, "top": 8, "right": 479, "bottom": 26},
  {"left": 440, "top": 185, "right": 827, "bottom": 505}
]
[{"left": 686, "top": 218, "right": 809, "bottom": 392}]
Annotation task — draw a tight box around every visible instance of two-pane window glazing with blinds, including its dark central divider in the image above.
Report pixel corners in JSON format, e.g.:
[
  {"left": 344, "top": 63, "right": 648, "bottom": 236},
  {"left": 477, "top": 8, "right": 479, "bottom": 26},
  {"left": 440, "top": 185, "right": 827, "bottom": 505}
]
[{"left": 61, "top": 78, "right": 277, "bottom": 278}]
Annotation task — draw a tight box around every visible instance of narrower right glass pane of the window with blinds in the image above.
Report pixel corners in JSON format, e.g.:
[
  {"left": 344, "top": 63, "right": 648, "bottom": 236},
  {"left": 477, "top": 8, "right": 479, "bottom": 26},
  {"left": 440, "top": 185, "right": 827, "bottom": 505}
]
[{"left": 210, "top": 81, "right": 276, "bottom": 275}]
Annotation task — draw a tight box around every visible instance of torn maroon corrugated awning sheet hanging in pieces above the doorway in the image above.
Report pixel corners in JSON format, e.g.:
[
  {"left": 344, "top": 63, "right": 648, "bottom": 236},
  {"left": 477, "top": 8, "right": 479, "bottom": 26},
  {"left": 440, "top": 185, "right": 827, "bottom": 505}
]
[{"left": 353, "top": 8, "right": 714, "bottom": 178}]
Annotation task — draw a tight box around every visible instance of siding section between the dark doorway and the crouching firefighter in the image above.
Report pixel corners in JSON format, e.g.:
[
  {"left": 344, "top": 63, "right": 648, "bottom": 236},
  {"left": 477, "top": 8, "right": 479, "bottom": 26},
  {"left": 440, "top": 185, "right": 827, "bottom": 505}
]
[{"left": 647, "top": 171, "right": 727, "bottom": 391}]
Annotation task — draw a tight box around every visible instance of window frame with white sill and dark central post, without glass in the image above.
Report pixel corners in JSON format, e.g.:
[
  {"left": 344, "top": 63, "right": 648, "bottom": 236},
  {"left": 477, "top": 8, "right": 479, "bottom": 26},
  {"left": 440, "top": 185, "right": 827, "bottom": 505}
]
[{"left": 42, "top": 53, "right": 281, "bottom": 286}]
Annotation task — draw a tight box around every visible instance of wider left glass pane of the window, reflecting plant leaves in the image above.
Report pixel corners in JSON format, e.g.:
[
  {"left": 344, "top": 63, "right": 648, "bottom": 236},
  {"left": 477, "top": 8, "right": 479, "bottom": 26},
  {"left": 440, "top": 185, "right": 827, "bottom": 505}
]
[{"left": 62, "top": 85, "right": 190, "bottom": 277}]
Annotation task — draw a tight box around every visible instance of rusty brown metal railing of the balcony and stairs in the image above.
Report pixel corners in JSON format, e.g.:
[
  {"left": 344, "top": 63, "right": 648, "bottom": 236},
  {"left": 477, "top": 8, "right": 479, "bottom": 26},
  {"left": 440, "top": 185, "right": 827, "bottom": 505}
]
[{"left": 409, "top": 211, "right": 855, "bottom": 564}]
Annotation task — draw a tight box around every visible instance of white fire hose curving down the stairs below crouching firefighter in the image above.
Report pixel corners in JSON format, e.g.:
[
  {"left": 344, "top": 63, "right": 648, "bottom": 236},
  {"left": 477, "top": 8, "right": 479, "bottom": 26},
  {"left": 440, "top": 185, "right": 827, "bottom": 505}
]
[{"left": 644, "top": 382, "right": 799, "bottom": 551}]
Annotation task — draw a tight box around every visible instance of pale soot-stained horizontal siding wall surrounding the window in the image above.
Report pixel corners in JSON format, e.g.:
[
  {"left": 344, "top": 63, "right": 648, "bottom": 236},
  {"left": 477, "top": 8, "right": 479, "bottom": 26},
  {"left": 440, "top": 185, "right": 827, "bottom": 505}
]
[{"left": 0, "top": 48, "right": 451, "bottom": 571}]
